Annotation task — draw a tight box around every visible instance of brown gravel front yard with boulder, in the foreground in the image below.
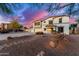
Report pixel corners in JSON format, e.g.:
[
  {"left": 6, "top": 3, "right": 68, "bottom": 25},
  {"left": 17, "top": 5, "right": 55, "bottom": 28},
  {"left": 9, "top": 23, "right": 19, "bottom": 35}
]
[{"left": 0, "top": 34, "right": 79, "bottom": 56}]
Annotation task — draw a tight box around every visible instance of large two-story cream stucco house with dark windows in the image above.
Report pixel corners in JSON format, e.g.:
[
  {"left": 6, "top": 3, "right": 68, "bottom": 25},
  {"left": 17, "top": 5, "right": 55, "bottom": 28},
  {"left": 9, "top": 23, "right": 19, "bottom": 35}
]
[{"left": 33, "top": 15, "right": 70, "bottom": 34}]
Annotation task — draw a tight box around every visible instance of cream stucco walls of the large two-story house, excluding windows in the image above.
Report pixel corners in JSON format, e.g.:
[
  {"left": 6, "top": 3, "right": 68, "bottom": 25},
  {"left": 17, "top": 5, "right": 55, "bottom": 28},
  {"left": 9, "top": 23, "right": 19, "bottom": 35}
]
[{"left": 33, "top": 16, "right": 70, "bottom": 34}]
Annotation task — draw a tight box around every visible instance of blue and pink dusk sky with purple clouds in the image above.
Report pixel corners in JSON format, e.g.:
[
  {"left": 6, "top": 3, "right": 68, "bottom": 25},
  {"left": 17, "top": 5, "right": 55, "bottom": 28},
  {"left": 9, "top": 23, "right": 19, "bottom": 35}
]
[{"left": 0, "top": 3, "right": 79, "bottom": 26}]
